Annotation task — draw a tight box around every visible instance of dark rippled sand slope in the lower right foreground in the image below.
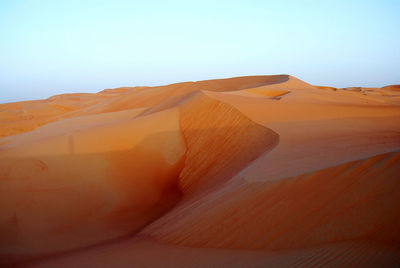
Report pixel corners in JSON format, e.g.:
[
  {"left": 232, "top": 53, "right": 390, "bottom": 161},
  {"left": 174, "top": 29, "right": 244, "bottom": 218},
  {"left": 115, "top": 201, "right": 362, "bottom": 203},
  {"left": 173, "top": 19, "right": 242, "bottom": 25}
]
[{"left": 142, "top": 152, "right": 400, "bottom": 250}]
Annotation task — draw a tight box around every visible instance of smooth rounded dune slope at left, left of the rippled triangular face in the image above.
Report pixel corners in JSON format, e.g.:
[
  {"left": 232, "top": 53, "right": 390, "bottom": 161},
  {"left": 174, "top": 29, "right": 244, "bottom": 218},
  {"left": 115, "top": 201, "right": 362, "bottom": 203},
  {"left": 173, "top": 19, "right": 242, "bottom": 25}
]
[{"left": 0, "top": 110, "right": 186, "bottom": 258}]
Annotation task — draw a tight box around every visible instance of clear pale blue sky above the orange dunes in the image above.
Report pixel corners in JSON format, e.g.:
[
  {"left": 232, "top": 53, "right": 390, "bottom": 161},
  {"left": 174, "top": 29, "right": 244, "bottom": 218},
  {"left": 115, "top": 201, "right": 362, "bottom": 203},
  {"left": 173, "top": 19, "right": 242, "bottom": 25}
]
[{"left": 0, "top": 0, "right": 400, "bottom": 103}]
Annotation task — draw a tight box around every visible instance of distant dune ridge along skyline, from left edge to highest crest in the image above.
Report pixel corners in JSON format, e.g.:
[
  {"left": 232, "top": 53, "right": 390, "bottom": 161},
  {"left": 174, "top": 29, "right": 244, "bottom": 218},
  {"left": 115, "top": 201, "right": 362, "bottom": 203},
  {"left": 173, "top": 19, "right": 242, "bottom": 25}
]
[{"left": 0, "top": 75, "right": 289, "bottom": 137}]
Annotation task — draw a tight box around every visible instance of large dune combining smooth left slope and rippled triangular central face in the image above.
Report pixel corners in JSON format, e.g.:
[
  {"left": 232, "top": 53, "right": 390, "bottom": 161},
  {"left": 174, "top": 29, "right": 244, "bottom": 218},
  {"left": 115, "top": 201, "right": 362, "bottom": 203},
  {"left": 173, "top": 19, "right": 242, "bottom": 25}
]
[{"left": 0, "top": 89, "right": 278, "bottom": 264}]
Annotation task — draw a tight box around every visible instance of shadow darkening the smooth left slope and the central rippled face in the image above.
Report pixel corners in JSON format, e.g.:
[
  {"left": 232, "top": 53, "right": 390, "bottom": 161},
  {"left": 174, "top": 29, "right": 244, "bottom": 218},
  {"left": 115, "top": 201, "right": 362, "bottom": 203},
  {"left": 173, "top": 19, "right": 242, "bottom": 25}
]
[{"left": 0, "top": 125, "right": 278, "bottom": 265}]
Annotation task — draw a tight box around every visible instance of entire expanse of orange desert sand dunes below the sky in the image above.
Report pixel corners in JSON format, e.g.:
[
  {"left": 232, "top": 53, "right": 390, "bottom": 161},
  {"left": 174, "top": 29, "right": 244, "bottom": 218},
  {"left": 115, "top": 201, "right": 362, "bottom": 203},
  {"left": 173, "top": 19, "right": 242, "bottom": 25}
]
[{"left": 0, "top": 75, "right": 400, "bottom": 267}]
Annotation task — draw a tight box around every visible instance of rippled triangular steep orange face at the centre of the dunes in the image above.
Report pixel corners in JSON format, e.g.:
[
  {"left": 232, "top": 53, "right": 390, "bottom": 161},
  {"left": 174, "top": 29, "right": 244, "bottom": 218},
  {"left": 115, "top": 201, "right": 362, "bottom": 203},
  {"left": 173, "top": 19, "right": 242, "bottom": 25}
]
[{"left": 179, "top": 93, "right": 279, "bottom": 192}]
